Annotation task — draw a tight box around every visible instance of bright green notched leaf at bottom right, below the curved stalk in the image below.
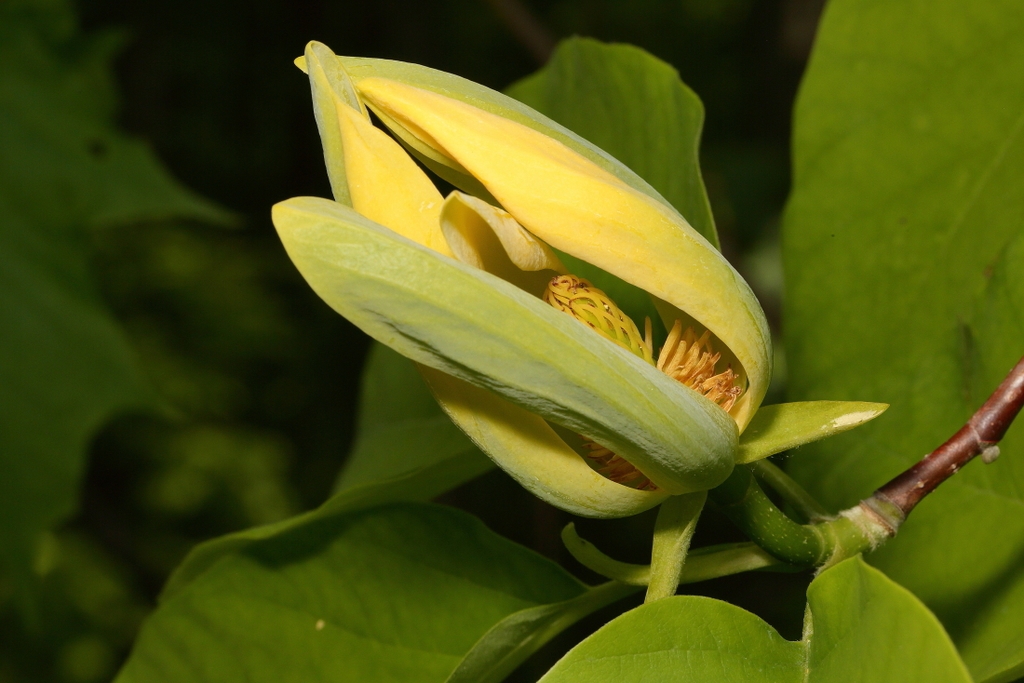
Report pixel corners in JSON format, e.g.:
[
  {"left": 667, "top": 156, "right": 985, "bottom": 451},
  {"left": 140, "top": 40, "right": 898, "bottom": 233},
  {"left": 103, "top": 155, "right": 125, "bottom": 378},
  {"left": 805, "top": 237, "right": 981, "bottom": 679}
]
[{"left": 541, "top": 557, "right": 971, "bottom": 683}]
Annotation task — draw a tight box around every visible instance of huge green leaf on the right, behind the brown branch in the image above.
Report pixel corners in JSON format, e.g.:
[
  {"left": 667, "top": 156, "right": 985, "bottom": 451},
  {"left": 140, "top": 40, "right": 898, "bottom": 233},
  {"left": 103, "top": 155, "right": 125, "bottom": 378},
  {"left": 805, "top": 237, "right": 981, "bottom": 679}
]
[{"left": 783, "top": 0, "right": 1024, "bottom": 680}]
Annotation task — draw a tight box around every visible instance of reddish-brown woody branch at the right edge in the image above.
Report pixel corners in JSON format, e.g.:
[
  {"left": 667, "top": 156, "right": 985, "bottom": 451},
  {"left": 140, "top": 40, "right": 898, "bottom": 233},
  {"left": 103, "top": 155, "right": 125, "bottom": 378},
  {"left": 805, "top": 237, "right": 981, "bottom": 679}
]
[{"left": 864, "top": 358, "right": 1024, "bottom": 520}]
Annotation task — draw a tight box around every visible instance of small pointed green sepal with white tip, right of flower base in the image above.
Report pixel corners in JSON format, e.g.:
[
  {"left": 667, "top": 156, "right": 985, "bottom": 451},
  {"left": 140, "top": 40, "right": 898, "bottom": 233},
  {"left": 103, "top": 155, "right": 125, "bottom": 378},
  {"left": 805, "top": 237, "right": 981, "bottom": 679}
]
[{"left": 736, "top": 400, "right": 888, "bottom": 463}]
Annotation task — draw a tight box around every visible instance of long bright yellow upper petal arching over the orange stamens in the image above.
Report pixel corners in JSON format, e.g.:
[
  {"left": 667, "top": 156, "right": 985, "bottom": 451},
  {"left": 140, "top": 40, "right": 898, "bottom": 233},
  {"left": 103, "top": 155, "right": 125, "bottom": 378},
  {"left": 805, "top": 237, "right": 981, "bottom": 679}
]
[{"left": 356, "top": 78, "right": 771, "bottom": 428}]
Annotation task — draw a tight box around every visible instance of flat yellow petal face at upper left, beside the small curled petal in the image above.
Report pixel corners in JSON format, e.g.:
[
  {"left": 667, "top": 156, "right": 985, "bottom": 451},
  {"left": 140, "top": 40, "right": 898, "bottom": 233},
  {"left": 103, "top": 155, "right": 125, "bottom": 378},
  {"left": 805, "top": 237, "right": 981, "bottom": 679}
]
[{"left": 338, "top": 105, "right": 453, "bottom": 256}]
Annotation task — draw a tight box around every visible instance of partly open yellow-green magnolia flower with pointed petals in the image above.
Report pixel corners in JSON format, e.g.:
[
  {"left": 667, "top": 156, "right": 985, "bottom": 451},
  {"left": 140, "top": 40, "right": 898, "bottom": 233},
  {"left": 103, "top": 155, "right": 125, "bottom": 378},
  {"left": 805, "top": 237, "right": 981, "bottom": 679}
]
[{"left": 273, "top": 43, "right": 881, "bottom": 517}]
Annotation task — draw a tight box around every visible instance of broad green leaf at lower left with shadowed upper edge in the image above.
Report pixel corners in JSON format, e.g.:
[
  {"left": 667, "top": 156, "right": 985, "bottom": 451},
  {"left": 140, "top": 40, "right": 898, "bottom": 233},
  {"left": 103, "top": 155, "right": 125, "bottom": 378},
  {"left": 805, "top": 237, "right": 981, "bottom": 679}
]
[{"left": 117, "top": 504, "right": 586, "bottom": 683}]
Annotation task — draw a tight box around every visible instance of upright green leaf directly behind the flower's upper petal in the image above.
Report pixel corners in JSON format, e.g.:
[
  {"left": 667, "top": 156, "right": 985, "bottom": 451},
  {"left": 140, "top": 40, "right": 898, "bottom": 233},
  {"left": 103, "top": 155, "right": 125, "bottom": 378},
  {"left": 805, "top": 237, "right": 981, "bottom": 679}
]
[{"left": 507, "top": 38, "right": 718, "bottom": 343}]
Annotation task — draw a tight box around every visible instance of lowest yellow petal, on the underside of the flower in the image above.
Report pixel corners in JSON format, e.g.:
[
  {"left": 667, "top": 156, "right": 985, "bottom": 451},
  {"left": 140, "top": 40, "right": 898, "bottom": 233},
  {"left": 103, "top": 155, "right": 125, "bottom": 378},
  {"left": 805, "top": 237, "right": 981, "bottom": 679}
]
[{"left": 420, "top": 366, "right": 669, "bottom": 518}]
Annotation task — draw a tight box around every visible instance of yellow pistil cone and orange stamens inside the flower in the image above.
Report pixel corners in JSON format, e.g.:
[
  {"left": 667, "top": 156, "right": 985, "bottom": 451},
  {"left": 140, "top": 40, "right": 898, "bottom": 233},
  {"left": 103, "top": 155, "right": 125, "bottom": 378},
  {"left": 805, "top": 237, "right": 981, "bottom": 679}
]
[{"left": 543, "top": 275, "right": 742, "bottom": 490}]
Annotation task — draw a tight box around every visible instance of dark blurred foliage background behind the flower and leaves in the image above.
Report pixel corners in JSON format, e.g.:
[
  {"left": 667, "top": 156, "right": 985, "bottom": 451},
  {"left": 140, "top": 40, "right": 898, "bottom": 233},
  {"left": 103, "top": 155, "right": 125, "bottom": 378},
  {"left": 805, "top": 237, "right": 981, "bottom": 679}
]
[{"left": 0, "top": 0, "right": 822, "bottom": 683}]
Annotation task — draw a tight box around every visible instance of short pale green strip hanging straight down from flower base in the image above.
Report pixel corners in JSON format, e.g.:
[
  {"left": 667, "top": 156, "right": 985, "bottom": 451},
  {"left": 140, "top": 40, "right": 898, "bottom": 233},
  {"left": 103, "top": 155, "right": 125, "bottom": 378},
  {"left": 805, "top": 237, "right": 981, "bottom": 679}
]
[{"left": 644, "top": 490, "right": 708, "bottom": 602}]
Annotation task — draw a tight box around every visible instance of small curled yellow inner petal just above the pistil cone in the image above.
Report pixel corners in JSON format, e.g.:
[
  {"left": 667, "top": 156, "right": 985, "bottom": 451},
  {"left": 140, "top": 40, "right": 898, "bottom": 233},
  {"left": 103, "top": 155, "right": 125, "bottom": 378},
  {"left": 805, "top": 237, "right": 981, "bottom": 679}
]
[{"left": 440, "top": 191, "right": 564, "bottom": 296}]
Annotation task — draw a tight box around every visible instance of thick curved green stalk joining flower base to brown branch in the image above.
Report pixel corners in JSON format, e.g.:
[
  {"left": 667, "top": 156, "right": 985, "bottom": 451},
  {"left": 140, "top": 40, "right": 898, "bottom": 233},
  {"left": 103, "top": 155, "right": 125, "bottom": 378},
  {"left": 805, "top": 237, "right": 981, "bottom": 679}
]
[{"left": 711, "top": 466, "right": 879, "bottom": 567}]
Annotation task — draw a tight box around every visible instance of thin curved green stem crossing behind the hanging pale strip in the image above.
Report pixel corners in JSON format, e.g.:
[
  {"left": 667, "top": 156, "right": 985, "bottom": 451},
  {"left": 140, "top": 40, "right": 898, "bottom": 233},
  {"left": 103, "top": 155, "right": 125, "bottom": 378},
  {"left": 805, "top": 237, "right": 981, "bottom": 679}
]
[{"left": 562, "top": 523, "right": 788, "bottom": 586}]
